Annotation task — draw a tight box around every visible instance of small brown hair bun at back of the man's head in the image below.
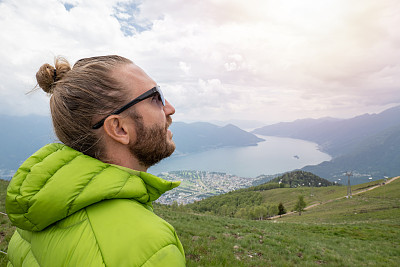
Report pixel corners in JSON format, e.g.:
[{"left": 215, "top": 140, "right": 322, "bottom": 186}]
[{"left": 36, "top": 57, "right": 71, "bottom": 94}]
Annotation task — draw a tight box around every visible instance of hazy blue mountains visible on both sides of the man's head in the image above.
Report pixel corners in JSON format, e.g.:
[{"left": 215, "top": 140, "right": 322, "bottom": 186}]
[{"left": 0, "top": 115, "right": 263, "bottom": 179}]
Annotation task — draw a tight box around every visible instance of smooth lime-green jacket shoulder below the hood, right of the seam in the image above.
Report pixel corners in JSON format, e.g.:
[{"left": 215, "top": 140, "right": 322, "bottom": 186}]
[{"left": 86, "top": 199, "right": 184, "bottom": 266}]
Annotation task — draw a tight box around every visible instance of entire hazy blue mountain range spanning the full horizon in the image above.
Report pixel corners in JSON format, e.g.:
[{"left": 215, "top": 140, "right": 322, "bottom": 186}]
[{"left": 0, "top": 106, "right": 400, "bottom": 181}]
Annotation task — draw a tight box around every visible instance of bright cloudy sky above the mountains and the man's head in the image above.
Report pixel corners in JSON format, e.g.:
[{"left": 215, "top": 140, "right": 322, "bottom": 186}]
[{"left": 0, "top": 0, "right": 400, "bottom": 124}]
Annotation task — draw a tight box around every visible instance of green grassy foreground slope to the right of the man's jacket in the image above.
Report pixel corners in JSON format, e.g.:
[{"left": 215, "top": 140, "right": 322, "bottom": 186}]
[{"left": 157, "top": 203, "right": 400, "bottom": 266}]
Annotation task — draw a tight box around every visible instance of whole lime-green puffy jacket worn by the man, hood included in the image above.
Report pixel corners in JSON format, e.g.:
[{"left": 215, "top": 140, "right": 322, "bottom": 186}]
[{"left": 6, "top": 144, "right": 185, "bottom": 267}]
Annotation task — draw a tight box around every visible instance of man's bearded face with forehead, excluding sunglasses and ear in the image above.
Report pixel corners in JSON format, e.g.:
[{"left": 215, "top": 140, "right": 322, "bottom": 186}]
[{"left": 112, "top": 64, "right": 175, "bottom": 168}]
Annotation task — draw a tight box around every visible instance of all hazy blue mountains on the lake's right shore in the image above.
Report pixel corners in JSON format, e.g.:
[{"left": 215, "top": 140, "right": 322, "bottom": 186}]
[{"left": 252, "top": 106, "right": 400, "bottom": 181}]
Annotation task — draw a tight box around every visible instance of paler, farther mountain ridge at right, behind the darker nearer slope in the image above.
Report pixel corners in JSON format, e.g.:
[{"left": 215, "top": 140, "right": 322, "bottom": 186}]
[{"left": 252, "top": 106, "right": 400, "bottom": 157}]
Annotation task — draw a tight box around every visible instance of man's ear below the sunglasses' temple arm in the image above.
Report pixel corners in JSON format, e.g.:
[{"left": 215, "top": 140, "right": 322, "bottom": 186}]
[{"left": 103, "top": 115, "right": 136, "bottom": 145}]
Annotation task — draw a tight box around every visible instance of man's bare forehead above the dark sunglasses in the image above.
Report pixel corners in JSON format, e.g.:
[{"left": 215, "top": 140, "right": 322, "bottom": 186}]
[{"left": 112, "top": 63, "right": 156, "bottom": 97}]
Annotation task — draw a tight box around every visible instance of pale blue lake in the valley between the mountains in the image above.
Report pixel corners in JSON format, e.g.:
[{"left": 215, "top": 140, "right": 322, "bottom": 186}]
[{"left": 148, "top": 135, "right": 331, "bottom": 178}]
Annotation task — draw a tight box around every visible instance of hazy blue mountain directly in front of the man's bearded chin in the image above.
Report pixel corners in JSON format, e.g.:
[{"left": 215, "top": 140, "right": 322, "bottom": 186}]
[{"left": 170, "top": 122, "right": 264, "bottom": 154}]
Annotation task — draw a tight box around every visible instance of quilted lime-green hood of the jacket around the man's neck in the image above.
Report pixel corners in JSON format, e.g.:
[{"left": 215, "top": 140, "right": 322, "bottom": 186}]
[{"left": 6, "top": 144, "right": 180, "bottom": 231}]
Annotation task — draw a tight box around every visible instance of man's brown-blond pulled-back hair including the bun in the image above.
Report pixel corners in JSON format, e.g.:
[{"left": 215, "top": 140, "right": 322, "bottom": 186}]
[{"left": 36, "top": 55, "right": 132, "bottom": 159}]
